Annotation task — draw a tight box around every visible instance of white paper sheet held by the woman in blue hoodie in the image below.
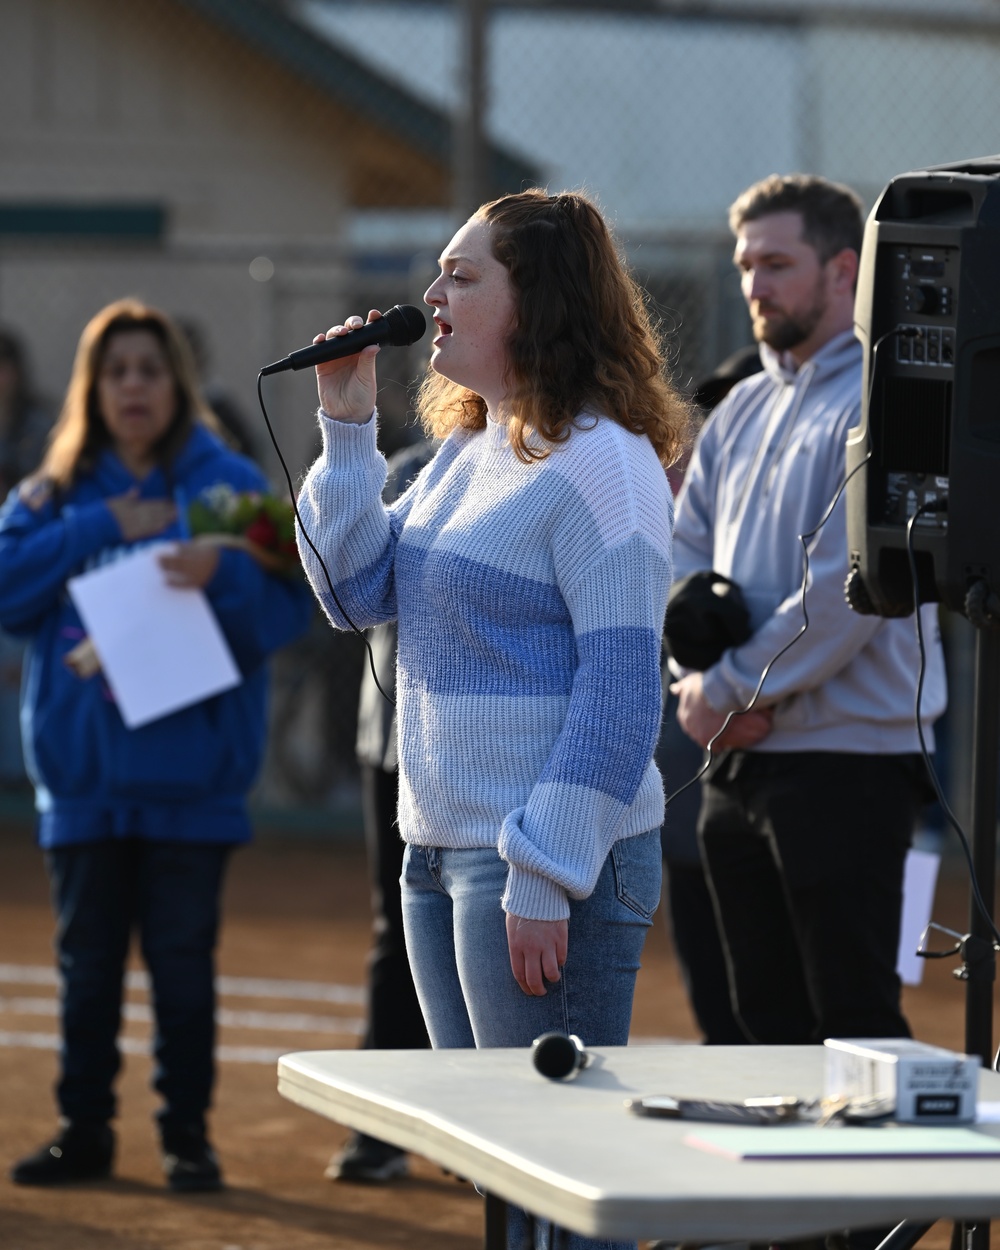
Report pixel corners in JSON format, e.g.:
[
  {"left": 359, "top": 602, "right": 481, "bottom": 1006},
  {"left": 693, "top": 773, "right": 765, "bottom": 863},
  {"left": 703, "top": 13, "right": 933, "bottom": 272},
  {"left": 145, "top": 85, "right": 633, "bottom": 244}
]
[{"left": 68, "top": 543, "right": 241, "bottom": 729}]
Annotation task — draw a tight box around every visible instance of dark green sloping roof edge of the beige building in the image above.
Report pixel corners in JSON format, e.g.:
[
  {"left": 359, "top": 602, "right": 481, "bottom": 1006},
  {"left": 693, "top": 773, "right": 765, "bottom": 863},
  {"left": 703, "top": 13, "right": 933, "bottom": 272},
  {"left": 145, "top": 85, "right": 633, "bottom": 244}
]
[{"left": 178, "top": 0, "right": 539, "bottom": 195}]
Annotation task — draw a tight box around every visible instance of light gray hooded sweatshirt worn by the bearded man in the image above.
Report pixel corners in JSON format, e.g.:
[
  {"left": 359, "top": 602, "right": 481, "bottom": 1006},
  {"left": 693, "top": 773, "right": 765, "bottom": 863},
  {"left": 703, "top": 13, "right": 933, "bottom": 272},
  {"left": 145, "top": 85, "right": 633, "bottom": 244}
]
[{"left": 674, "top": 331, "right": 945, "bottom": 755}]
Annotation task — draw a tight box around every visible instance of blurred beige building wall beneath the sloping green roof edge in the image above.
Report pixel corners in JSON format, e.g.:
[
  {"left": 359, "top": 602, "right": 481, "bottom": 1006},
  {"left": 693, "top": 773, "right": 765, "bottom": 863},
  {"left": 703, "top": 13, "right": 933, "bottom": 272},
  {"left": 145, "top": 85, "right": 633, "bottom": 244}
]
[{"left": 0, "top": 0, "right": 446, "bottom": 476}]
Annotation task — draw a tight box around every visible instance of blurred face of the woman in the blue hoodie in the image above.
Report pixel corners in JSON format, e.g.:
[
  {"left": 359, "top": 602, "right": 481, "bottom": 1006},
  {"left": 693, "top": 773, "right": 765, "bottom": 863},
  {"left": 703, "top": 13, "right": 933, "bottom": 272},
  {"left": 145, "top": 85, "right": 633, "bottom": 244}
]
[{"left": 98, "top": 330, "right": 178, "bottom": 463}]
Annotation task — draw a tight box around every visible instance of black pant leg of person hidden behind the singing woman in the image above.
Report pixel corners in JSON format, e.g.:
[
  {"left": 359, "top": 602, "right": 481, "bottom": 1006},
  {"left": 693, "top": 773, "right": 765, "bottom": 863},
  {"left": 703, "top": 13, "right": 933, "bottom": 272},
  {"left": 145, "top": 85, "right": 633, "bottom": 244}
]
[{"left": 361, "top": 765, "right": 430, "bottom": 1050}]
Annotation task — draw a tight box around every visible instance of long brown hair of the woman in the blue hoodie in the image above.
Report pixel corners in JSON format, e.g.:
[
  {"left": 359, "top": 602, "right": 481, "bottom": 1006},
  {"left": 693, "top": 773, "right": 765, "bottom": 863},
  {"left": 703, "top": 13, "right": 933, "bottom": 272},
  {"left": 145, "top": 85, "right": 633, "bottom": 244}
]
[{"left": 33, "top": 299, "right": 219, "bottom": 490}]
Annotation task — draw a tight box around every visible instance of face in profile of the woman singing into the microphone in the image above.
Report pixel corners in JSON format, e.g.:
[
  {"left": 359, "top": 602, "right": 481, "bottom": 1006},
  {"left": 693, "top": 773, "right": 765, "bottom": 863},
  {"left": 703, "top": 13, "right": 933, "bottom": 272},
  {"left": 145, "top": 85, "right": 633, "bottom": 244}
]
[{"left": 424, "top": 219, "right": 515, "bottom": 414}]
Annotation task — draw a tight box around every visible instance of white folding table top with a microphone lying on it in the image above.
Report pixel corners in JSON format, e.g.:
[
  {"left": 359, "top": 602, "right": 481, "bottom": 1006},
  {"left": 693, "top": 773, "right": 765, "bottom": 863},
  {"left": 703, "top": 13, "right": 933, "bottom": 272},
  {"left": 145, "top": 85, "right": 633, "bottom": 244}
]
[{"left": 278, "top": 1045, "right": 1000, "bottom": 1241}]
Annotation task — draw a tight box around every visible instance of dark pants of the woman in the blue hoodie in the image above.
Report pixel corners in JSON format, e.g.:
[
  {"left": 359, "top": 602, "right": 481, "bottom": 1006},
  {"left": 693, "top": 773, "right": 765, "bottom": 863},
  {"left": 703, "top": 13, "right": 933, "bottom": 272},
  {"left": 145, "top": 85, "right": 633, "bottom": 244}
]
[{"left": 46, "top": 838, "right": 230, "bottom": 1130}]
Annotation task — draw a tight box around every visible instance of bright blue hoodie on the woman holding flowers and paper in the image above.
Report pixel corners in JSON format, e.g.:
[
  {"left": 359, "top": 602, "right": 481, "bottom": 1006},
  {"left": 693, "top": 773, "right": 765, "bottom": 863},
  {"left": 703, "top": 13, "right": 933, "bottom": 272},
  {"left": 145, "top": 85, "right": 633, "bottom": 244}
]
[{"left": 0, "top": 428, "right": 313, "bottom": 848}]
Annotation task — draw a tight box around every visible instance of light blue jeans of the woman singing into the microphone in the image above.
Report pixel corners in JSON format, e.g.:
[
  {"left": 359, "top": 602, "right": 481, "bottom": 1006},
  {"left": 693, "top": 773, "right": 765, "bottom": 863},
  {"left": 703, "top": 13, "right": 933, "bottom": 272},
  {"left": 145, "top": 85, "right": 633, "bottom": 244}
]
[{"left": 403, "top": 830, "right": 661, "bottom": 1250}]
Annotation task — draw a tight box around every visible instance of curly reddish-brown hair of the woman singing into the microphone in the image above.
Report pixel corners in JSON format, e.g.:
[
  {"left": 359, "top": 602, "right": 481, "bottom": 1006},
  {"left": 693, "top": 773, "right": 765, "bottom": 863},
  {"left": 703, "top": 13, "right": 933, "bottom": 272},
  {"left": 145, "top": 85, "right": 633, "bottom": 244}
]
[{"left": 418, "top": 189, "right": 690, "bottom": 465}]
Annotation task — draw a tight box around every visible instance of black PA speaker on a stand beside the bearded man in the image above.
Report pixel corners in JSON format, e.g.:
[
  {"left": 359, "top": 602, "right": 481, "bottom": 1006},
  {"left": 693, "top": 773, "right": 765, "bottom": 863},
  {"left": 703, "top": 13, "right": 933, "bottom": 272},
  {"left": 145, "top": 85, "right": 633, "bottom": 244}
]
[{"left": 846, "top": 156, "right": 1000, "bottom": 616}]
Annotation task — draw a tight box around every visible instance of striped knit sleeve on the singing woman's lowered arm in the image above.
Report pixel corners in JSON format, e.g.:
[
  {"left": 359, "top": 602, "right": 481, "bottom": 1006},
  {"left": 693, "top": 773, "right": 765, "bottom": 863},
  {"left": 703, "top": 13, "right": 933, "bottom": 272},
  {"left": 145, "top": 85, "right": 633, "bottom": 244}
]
[{"left": 499, "top": 435, "right": 673, "bottom": 920}]
